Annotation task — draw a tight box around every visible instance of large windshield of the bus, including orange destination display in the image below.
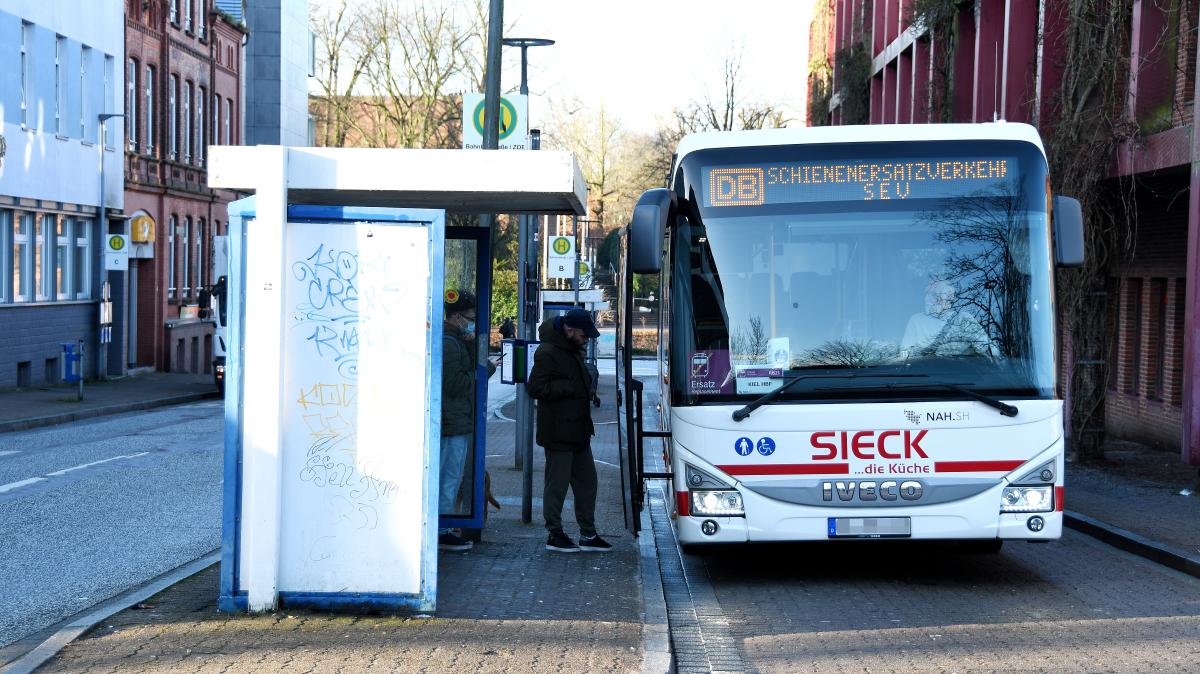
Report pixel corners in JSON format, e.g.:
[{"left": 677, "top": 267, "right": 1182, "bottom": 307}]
[{"left": 668, "top": 142, "right": 1055, "bottom": 404}]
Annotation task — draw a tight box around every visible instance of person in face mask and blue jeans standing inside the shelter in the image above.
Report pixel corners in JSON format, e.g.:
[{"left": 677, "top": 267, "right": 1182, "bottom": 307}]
[{"left": 438, "top": 290, "right": 496, "bottom": 550}]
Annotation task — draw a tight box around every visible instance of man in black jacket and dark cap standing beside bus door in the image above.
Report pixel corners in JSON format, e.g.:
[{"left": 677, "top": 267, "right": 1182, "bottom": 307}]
[{"left": 526, "top": 309, "right": 612, "bottom": 553}]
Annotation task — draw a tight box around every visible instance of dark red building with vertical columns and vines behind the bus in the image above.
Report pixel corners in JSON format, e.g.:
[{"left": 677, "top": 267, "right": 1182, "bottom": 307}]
[{"left": 809, "top": 0, "right": 1200, "bottom": 464}]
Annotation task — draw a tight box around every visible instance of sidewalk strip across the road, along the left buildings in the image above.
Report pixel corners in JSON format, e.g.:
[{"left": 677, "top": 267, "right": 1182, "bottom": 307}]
[{"left": 0, "top": 372, "right": 217, "bottom": 433}]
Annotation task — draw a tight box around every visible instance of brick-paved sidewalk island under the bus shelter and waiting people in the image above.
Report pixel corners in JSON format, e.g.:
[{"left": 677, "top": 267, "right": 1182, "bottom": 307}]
[{"left": 28, "top": 371, "right": 643, "bottom": 674}]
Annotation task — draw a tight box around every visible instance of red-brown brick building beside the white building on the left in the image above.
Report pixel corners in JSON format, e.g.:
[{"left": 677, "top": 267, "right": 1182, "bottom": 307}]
[{"left": 124, "top": 0, "right": 247, "bottom": 373}]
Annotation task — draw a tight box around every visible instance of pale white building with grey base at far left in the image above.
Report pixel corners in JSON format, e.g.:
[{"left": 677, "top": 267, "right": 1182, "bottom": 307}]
[{"left": 0, "top": 0, "right": 125, "bottom": 387}]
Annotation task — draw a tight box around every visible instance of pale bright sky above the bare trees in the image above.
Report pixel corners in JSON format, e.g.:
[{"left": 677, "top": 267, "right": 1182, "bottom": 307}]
[{"left": 311, "top": 0, "right": 812, "bottom": 132}]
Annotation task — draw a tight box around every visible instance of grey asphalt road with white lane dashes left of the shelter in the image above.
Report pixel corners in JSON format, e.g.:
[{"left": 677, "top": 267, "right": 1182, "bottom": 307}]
[{"left": 0, "top": 401, "right": 223, "bottom": 648}]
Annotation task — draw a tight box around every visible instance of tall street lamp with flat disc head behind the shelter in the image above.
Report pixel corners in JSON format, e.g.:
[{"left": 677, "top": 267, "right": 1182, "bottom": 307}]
[{"left": 504, "top": 37, "right": 554, "bottom": 523}]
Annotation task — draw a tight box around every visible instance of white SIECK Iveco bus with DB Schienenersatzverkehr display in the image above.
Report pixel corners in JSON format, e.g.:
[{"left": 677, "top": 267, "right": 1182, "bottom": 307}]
[{"left": 617, "top": 122, "right": 1084, "bottom": 550}]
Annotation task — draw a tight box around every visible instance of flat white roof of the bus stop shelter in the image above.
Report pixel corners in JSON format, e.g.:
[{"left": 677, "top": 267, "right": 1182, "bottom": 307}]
[{"left": 209, "top": 145, "right": 587, "bottom": 215}]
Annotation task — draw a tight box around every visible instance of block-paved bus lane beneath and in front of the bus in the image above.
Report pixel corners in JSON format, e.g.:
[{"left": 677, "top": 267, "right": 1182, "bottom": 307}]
[{"left": 677, "top": 503, "right": 1200, "bottom": 673}]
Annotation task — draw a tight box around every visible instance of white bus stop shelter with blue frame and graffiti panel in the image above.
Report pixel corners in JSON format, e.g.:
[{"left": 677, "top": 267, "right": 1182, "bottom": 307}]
[{"left": 209, "top": 145, "right": 587, "bottom": 610}]
